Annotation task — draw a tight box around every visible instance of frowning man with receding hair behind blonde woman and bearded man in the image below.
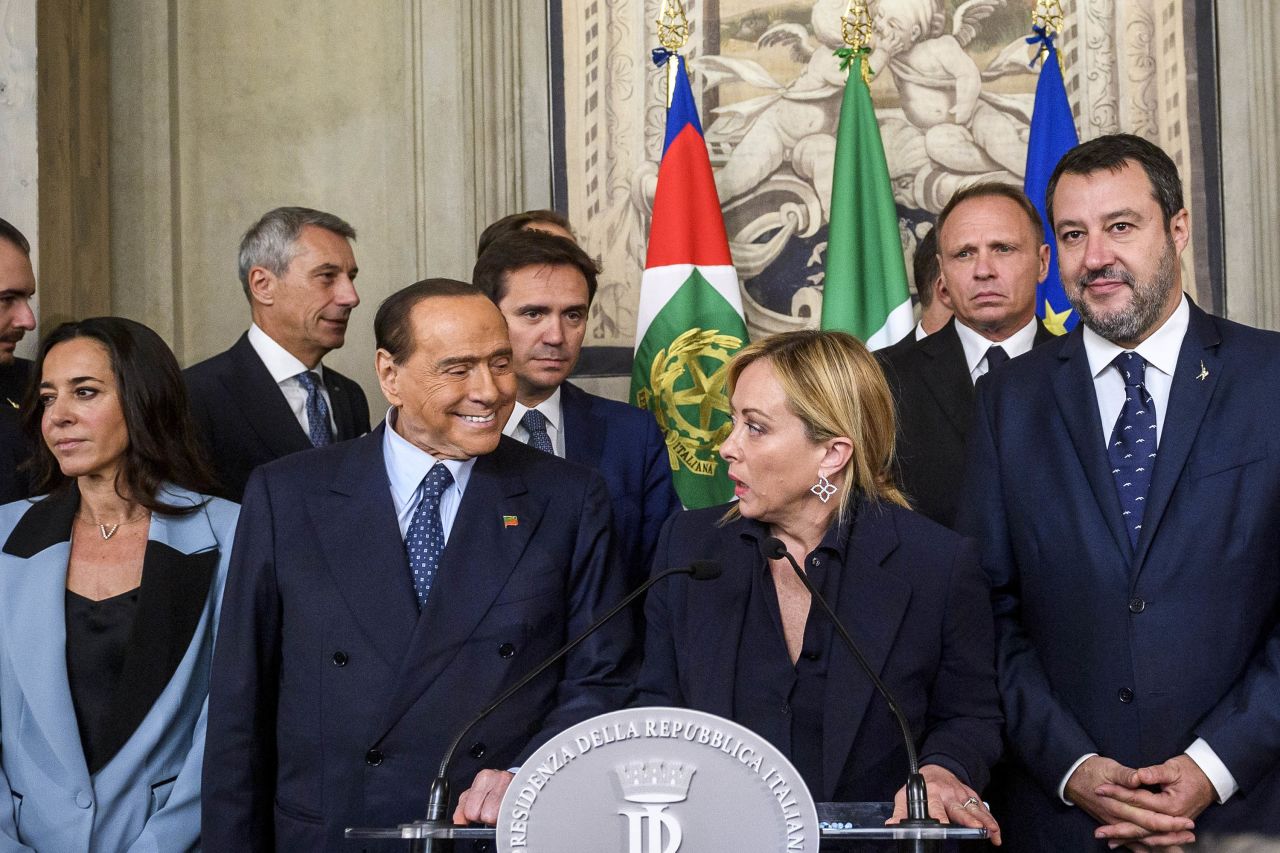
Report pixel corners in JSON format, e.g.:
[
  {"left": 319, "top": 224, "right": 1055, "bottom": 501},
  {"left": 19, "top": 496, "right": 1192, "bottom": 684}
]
[{"left": 881, "top": 183, "right": 1053, "bottom": 528}]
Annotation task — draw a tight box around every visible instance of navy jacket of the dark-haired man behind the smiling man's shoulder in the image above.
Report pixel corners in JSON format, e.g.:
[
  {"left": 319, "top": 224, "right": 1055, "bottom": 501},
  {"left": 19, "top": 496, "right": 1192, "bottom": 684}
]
[{"left": 561, "top": 382, "right": 680, "bottom": 589}]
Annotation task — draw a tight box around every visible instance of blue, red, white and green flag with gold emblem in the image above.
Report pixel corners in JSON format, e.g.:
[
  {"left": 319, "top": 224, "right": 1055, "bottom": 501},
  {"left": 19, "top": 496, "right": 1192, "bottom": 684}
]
[{"left": 631, "top": 55, "right": 746, "bottom": 508}]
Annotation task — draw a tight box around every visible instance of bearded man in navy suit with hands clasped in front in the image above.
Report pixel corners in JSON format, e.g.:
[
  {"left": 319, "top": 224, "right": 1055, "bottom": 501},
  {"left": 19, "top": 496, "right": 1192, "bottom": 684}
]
[{"left": 959, "top": 134, "right": 1280, "bottom": 850}]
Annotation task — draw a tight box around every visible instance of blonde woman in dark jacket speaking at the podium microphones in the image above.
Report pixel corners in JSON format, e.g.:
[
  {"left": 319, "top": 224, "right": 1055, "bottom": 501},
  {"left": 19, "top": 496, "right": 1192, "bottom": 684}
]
[{"left": 639, "top": 330, "right": 1001, "bottom": 844}]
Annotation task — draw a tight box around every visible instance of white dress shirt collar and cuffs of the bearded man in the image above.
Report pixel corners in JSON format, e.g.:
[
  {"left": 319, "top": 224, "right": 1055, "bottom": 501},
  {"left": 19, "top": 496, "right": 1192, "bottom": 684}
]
[{"left": 1057, "top": 295, "right": 1239, "bottom": 806}]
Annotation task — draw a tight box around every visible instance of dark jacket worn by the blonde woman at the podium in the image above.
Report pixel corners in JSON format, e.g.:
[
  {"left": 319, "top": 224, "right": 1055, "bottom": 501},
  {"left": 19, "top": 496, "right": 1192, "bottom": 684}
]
[{"left": 639, "top": 503, "right": 1000, "bottom": 802}]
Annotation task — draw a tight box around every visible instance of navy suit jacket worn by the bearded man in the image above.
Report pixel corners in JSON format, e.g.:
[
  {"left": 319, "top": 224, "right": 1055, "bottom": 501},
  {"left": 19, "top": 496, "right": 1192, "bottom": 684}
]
[{"left": 959, "top": 300, "right": 1280, "bottom": 850}]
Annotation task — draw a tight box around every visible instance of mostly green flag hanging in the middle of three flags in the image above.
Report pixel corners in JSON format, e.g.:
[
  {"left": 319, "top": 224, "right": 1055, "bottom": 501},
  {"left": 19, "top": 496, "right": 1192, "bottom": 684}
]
[{"left": 822, "top": 53, "right": 915, "bottom": 350}]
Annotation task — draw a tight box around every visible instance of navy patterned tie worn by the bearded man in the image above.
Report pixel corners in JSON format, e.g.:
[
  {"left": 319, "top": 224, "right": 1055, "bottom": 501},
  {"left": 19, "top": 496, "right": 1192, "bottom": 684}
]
[{"left": 1107, "top": 352, "right": 1156, "bottom": 548}]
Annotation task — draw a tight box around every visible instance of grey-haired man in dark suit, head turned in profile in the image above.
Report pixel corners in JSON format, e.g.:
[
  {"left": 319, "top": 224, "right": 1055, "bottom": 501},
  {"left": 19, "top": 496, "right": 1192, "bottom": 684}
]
[{"left": 186, "top": 207, "right": 369, "bottom": 501}]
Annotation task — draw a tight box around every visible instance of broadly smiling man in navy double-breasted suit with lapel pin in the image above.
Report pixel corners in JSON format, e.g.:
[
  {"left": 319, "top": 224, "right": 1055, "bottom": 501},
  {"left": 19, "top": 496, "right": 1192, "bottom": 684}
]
[{"left": 202, "top": 279, "right": 632, "bottom": 853}]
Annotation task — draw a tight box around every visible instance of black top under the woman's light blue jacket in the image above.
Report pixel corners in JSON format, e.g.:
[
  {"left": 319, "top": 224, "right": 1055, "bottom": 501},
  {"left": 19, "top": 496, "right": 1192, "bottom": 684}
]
[{"left": 67, "top": 587, "right": 142, "bottom": 774}]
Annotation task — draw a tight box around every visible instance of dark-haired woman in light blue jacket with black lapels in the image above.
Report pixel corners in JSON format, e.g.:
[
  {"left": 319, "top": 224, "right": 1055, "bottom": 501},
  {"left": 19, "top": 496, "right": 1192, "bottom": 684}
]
[{"left": 0, "top": 318, "right": 239, "bottom": 853}]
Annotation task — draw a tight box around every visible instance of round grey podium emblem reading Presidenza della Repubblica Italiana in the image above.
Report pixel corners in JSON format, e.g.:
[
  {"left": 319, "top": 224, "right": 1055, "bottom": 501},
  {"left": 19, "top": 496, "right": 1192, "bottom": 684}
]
[{"left": 497, "top": 708, "right": 820, "bottom": 853}]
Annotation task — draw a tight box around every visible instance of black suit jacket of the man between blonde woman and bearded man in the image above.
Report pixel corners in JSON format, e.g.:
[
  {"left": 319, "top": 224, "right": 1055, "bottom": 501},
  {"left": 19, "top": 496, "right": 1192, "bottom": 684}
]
[{"left": 881, "top": 318, "right": 1053, "bottom": 528}]
